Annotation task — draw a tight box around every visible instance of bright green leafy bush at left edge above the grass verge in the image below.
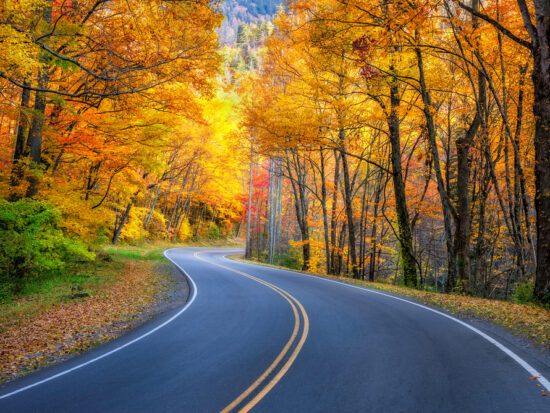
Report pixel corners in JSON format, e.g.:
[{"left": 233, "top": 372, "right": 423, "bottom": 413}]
[{"left": 0, "top": 199, "right": 95, "bottom": 289}]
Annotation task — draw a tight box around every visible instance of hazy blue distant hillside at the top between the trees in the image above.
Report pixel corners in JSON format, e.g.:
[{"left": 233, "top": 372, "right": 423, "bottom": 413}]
[{"left": 219, "top": 0, "right": 283, "bottom": 44}]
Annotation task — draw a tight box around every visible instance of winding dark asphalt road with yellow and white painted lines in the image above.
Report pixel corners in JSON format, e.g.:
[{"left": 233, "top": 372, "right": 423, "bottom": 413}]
[{"left": 0, "top": 249, "right": 550, "bottom": 413}]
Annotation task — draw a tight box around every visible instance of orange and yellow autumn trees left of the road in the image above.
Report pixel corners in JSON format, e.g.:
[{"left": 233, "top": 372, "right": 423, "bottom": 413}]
[{"left": 0, "top": 0, "right": 248, "bottom": 253}]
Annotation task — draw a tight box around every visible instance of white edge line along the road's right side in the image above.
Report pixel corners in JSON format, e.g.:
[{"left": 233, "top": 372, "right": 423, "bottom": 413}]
[{"left": 224, "top": 256, "right": 550, "bottom": 392}]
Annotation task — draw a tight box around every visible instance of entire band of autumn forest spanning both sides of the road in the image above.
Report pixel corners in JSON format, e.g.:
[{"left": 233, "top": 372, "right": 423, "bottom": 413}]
[{"left": 0, "top": 0, "right": 550, "bottom": 302}]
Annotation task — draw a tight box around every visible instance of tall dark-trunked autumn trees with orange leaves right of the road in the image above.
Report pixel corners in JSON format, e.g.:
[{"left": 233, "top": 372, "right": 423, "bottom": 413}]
[{"left": 242, "top": 0, "right": 550, "bottom": 300}]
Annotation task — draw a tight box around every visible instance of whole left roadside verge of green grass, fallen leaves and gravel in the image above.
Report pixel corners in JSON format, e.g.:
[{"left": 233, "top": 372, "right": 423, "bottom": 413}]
[{"left": 0, "top": 242, "right": 209, "bottom": 383}]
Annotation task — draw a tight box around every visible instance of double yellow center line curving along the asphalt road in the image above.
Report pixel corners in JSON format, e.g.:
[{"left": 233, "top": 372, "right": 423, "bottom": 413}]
[{"left": 195, "top": 252, "right": 309, "bottom": 413}]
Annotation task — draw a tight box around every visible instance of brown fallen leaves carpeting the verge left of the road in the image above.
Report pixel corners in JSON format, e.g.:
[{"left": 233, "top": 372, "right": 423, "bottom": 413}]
[{"left": 0, "top": 261, "right": 166, "bottom": 381}]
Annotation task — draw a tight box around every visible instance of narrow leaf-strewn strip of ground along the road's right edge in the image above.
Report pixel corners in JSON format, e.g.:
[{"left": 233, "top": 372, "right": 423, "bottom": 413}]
[{"left": 228, "top": 255, "right": 550, "bottom": 355}]
